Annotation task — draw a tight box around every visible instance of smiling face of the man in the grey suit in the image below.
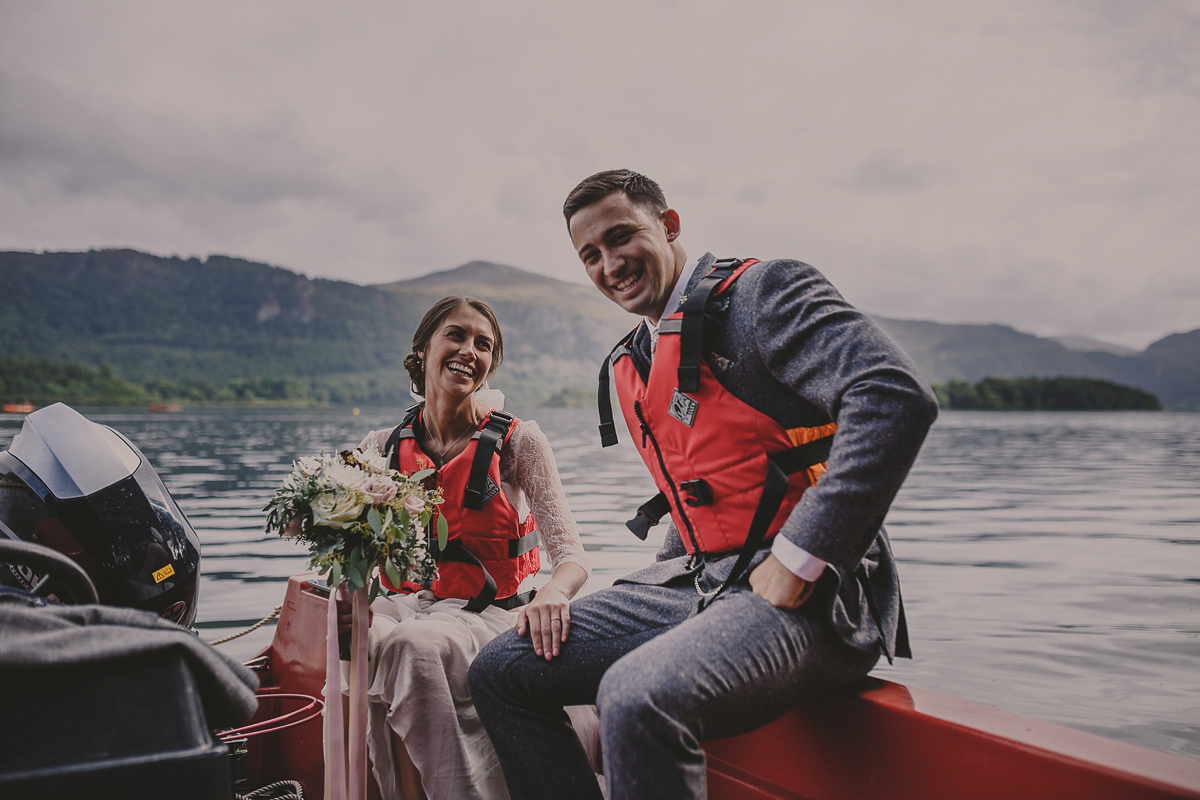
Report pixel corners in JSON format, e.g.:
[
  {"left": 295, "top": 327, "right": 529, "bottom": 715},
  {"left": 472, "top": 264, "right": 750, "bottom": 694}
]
[{"left": 570, "top": 192, "right": 682, "bottom": 323}]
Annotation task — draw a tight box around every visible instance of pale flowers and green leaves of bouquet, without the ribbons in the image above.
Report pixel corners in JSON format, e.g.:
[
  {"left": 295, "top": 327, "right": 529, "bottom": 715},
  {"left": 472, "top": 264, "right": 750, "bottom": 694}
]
[{"left": 263, "top": 451, "right": 448, "bottom": 600}]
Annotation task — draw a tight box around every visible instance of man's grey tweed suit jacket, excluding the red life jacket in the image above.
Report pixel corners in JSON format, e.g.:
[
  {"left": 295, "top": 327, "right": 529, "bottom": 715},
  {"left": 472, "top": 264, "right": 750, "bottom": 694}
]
[{"left": 620, "top": 254, "right": 937, "bottom": 660}]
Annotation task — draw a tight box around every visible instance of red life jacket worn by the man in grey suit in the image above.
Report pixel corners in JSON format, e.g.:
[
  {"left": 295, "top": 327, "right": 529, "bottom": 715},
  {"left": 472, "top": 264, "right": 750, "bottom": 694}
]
[{"left": 599, "top": 259, "right": 838, "bottom": 604}]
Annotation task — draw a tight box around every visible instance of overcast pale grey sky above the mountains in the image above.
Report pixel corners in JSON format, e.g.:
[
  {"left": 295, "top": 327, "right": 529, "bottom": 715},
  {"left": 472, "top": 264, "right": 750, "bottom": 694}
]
[{"left": 0, "top": 0, "right": 1200, "bottom": 347}]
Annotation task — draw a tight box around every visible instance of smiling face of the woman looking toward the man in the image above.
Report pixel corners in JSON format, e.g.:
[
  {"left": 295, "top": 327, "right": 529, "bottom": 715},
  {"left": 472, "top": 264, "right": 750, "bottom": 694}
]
[{"left": 421, "top": 306, "right": 496, "bottom": 397}]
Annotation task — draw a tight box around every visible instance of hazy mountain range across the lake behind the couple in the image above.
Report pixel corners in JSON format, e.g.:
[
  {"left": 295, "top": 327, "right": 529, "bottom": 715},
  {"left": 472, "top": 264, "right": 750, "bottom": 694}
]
[{"left": 0, "top": 249, "right": 1200, "bottom": 409}]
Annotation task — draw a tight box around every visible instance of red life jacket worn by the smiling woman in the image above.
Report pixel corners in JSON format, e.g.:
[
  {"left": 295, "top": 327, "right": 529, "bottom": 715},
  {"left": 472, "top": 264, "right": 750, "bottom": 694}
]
[{"left": 380, "top": 405, "right": 540, "bottom": 612}]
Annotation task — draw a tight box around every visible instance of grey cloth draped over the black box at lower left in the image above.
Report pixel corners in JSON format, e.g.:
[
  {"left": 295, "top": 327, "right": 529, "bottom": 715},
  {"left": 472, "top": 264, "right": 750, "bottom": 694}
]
[{"left": 0, "top": 596, "right": 258, "bottom": 728}]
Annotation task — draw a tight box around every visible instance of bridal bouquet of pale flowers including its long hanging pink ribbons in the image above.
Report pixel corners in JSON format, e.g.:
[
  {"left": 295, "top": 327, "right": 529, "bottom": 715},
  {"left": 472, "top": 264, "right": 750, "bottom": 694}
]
[{"left": 263, "top": 451, "right": 448, "bottom": 800}]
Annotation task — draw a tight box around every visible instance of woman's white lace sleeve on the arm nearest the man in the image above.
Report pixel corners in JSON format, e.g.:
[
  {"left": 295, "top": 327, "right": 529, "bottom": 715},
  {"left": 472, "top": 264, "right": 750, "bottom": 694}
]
[{"left": 500, "top": 420, "right": 592, "bottom": 573}]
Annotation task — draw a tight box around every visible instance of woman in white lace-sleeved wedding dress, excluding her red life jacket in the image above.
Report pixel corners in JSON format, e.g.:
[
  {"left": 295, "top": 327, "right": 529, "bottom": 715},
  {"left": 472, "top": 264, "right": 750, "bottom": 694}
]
[{"left": 341, "top": 297, "right": 594, "bottom": 800}]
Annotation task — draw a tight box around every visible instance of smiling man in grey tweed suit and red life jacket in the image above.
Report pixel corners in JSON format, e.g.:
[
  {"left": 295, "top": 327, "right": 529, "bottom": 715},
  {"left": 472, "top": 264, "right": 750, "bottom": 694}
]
[{"left": 470, "top": 170, "right": 937, "bottom": 800}]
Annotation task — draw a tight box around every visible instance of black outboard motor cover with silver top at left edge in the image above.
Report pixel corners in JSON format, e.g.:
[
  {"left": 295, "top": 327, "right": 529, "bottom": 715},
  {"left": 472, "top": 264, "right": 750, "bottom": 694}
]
[{"left": 0, "top": 403, "right": 200, "bottom": 626}]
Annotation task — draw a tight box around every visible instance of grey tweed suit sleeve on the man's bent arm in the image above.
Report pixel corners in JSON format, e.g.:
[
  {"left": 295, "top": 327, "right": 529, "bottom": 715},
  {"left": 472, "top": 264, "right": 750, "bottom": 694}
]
[{"left": 736, "top": 261, "right": 937, "bottom": 573}]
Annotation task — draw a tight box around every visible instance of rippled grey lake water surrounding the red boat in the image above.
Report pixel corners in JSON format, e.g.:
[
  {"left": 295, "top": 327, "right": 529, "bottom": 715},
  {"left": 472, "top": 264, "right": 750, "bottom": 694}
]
[{"left": 0, "top": 409, "right": 1200, "bottom": 758}]
